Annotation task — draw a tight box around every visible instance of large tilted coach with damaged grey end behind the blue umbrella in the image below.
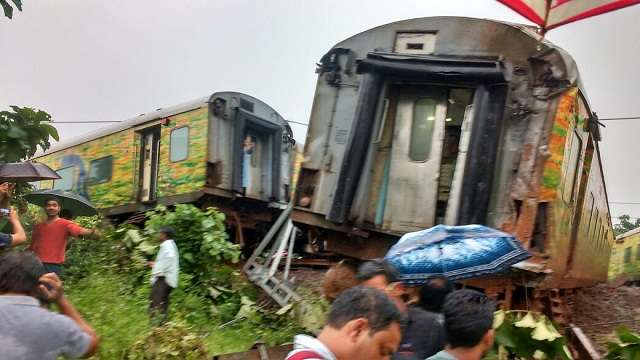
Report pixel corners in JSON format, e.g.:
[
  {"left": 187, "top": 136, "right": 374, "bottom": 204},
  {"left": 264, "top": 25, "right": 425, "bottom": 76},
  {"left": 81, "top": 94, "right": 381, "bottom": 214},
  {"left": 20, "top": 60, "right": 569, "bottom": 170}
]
[{"left": 293, "top": 17, "right": 613, "bottom": 299}]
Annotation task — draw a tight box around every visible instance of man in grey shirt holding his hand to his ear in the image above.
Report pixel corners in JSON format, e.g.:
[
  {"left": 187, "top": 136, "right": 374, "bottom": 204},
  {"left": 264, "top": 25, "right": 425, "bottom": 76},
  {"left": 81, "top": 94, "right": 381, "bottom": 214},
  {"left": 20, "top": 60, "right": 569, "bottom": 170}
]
[{"left": 0, "top": 252, "right": 99, "bottom": 360}]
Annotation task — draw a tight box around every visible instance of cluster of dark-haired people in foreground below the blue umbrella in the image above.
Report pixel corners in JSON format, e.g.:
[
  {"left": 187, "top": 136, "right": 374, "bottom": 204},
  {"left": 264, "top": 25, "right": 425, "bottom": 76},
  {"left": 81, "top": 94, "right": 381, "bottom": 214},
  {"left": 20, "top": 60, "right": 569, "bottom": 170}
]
[{"left": 286, "top": 259, "right": 495, "bottom": 360}]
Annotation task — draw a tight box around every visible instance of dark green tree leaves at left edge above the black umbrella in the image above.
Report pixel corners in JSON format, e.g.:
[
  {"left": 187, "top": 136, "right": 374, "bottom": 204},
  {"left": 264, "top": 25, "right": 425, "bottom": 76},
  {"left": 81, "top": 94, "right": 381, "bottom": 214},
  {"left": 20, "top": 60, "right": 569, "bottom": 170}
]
[{"left": 0, "top": 106, "right": 59, "bottom": 163}]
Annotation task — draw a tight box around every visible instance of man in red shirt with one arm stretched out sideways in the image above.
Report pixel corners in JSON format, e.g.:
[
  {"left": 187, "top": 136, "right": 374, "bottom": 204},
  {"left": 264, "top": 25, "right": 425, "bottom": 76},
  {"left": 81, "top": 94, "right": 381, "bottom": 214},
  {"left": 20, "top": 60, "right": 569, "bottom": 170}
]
[{"left": 30, "top": 198, "right": 98, "bottom": 276}]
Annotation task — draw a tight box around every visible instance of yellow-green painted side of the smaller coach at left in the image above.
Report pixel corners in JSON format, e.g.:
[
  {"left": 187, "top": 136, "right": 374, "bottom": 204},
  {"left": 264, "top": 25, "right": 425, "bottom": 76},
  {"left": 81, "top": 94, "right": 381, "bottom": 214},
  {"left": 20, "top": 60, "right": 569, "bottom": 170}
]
[{"left": 35, "top": 106, "right": 208, "bottom": 209}]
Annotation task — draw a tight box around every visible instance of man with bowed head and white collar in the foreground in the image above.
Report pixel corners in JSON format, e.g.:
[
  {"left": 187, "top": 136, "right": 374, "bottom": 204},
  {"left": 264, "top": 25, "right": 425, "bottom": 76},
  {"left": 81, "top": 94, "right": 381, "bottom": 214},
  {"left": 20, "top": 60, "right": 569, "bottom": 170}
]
[{"left": 286, "top": 286, "right": 401, "bottom": 360}]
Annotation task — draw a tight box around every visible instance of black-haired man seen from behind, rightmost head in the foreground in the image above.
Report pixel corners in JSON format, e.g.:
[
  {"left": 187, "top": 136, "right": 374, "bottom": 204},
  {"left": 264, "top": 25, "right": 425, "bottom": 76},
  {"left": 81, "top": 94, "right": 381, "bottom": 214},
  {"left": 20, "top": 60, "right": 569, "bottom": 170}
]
[{"left": 429, "top": 289, "right": 495, "bottom": 360}]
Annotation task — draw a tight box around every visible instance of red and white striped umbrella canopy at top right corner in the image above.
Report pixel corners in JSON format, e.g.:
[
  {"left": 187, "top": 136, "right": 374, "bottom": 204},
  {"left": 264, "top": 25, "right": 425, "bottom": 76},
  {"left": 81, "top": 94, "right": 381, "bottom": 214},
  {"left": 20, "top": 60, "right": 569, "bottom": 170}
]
[{"left": 498, "top": 0, "right": 640, "bottom": 33}]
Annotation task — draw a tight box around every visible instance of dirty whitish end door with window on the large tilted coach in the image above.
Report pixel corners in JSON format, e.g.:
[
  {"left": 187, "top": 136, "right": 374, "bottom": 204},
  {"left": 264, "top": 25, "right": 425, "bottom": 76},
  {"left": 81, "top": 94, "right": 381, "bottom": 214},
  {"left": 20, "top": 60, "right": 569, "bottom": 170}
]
[{"left": 384, "top": 87, "right": 447, "bottom": 231}]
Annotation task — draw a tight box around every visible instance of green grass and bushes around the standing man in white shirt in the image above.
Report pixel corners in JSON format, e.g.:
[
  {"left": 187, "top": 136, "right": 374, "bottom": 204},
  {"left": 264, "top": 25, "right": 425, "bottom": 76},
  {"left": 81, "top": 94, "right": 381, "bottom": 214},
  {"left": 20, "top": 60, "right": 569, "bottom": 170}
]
[{"left": 58, "top": 206, "right": 298, "bottom": 360}]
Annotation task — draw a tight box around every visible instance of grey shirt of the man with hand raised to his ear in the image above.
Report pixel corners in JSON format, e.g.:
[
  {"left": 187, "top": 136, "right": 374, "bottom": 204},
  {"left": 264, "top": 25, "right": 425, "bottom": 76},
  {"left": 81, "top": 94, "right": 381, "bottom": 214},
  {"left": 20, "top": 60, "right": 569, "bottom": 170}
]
[{"left": 0, "top": 295, "right": 91, "bottom": 360}]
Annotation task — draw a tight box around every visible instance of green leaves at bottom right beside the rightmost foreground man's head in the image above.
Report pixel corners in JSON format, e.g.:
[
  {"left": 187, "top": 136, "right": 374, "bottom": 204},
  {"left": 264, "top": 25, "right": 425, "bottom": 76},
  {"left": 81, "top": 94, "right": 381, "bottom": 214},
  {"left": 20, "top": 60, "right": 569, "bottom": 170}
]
[{"left": 493, "top": 310, "right": 572, "bottom": 359}]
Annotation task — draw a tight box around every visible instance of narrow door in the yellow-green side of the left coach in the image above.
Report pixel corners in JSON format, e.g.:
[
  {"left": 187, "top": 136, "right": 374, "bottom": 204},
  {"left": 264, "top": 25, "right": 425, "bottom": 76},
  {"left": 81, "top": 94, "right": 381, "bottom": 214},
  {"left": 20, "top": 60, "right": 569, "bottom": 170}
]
[{"left": 138, "top": 126, "right": 160, "bottom": 202}]
